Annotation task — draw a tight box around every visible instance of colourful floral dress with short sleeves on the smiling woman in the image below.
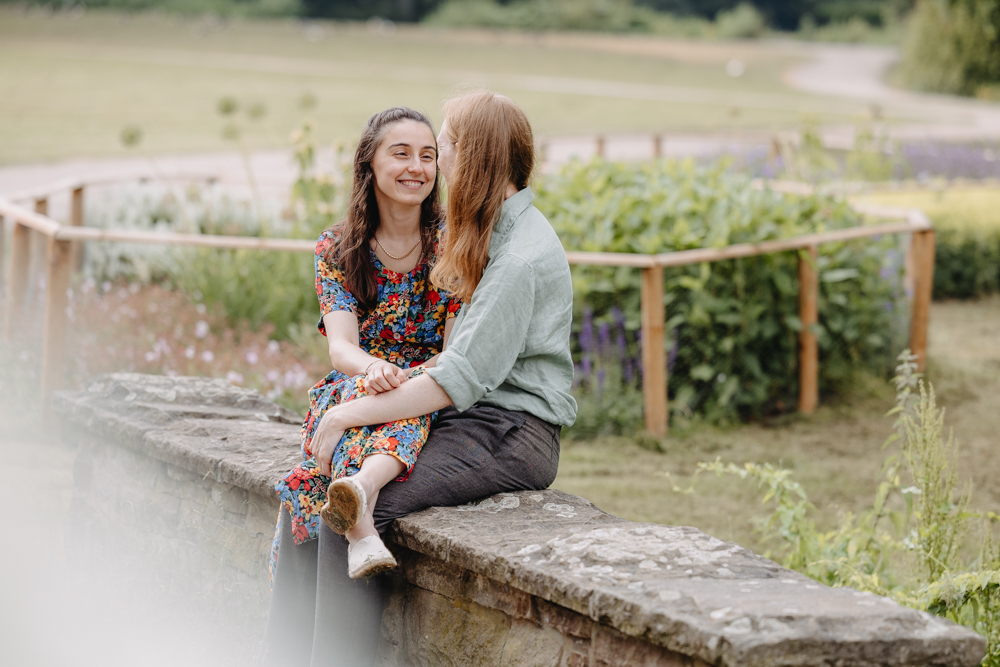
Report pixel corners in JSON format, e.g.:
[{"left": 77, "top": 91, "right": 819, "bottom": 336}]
[{"left": 270, "top": 229, "right": 461, "bottom": 576}]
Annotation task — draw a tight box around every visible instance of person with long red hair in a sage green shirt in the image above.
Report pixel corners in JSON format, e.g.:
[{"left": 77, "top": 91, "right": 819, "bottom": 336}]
[{"left": 265, "top": 91, "right": 576, "bottom": 666}]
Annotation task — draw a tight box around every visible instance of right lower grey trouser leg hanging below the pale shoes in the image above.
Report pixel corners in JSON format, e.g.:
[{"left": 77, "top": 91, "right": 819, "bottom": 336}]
[{"left": 312, "top": 523, "right": 383, "bottom": 667}]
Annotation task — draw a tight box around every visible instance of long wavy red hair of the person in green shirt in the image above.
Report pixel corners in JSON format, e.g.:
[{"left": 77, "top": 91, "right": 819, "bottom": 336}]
[{"left": 431, "top": 91, "right": 535, "bottom": 302}]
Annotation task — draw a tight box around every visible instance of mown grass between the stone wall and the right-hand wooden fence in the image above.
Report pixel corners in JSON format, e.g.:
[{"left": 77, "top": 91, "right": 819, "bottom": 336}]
[{"left": 553, "top": 298, "right": 1000, "bottom": 550}]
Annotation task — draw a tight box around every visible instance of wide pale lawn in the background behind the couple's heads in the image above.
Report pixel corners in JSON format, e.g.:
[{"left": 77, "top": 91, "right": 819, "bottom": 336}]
[{"left": 0, "top": 6, "right": 892, "bottom": 164}]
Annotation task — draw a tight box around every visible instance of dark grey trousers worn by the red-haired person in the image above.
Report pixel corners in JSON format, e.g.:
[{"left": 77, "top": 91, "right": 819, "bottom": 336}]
[{"left": 264, "top": 406, "right": 559, "bottom": 667}]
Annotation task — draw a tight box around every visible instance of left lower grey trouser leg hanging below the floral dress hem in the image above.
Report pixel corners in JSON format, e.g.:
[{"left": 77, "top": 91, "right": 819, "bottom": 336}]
[{"left": 263, "top": 508, "right": 318, "bottom": 667}]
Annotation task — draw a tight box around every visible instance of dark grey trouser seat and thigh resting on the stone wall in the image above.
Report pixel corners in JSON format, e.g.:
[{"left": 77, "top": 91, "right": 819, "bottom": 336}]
[{"left": 375, "top": 406, "right": 559, "bottom": 532}]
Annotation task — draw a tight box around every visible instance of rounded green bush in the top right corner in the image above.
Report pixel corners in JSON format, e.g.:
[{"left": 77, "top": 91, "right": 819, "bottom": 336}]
[{"left": 902, "top": 0, "right": 1000, "bottom": 97}]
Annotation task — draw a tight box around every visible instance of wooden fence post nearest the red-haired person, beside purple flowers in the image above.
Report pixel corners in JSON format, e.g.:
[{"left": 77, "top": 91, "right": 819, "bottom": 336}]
[{"left": 640, "top": 266, "right": 668, "bottom": 438}]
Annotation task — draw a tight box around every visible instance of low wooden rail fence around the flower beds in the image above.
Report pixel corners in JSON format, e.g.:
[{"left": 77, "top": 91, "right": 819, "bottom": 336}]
[{"left": 0, "top": 177, "right": 934, "bottom": 437}]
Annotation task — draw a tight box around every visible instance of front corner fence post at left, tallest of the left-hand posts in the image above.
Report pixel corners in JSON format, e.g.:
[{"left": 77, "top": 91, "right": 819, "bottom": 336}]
[{"left": 42, "top": 238, "right": 73, "bottom": 396}]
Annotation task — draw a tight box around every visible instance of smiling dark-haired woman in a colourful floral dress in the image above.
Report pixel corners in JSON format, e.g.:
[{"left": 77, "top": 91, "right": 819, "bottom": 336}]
[{"left": 271, "top": 107, "right": 458, "bottom": 578}]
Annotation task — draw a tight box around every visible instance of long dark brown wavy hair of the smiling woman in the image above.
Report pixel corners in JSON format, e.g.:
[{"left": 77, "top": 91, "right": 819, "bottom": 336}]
[{"left": 324, "top": 107, "right": 441, "bottom": 310}]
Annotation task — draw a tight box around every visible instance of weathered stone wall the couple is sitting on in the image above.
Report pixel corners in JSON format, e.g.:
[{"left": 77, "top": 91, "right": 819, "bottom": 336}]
[{"left": 56, "top": 374, "right": 985, "bottom": 667}]
